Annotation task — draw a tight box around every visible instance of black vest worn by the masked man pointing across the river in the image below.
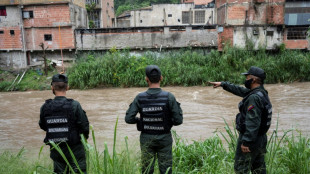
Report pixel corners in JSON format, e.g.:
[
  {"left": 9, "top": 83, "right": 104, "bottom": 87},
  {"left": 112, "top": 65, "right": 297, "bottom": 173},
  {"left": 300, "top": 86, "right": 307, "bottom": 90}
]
[{"left": 236, "top": 90, "right": 272, "bottom": 135}]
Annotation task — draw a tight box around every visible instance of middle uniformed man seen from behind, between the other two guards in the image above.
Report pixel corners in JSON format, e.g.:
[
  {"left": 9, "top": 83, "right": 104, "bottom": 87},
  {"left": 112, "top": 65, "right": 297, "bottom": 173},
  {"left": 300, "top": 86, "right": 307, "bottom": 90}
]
[{"left": 125, "top": 65, "right": 183, "bottom": 174}]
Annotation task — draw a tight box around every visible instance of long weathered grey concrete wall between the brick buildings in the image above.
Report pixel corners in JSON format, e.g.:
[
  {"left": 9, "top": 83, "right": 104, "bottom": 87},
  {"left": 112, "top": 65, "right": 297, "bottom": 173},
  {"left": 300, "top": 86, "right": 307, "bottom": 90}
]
[{"left": 75, "top": 26, "right": 218, "bottom": 50}]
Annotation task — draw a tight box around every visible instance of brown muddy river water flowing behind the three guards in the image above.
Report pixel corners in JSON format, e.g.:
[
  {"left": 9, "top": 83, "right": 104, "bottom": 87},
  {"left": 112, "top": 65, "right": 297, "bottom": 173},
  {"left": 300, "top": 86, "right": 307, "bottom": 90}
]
[{"left": 0, "top": 82, "right": 310, "bottom": 152}]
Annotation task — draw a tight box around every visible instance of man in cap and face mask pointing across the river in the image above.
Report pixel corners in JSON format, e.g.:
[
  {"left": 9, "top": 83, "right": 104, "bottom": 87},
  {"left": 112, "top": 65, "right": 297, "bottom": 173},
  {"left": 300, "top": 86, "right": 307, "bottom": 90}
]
[{"left": 210, "top": 66, "right": 272, "bottom": 174}]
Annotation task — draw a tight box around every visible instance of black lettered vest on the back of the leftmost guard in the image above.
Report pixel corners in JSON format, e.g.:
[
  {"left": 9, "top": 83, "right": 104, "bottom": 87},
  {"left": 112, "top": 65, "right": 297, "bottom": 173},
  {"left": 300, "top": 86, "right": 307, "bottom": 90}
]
[{"left": 43, "top": 99, "right": 80, "bottom": 145}]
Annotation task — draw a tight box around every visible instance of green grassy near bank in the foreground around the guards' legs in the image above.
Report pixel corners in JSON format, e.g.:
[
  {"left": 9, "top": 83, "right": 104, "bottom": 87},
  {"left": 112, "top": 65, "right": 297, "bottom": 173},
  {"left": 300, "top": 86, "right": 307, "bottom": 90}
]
[{"left": 0, "top": 119, "right": 310, "bottom": 174}]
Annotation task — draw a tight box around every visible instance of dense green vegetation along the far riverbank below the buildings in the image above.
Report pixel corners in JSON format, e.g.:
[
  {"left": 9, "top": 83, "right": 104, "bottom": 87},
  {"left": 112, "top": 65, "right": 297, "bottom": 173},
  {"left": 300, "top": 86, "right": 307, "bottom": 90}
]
[{"left": 68, "top": 48, "right": 310, "bottom": 89}]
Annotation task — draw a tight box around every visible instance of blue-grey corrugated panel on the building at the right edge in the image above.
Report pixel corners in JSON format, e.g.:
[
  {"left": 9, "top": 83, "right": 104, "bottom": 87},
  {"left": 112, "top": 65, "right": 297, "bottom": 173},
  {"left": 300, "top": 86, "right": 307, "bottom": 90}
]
[{"left": 285, "top": 13, "right": 310, "bottom": 25}]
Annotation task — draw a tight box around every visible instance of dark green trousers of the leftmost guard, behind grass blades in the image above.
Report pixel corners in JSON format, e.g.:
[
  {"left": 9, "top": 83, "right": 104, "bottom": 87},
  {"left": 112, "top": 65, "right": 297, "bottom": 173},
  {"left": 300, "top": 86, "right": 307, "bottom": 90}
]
[{"left": 50, "top": 143, "right": 86, "bottom": 174}]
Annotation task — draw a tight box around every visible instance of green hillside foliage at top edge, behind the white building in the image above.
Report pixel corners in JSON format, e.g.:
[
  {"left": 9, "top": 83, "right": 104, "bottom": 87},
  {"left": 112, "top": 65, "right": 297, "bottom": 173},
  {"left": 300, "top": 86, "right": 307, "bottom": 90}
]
[{"left": 114, "top": 0, "right": 180, "bottom": 16}]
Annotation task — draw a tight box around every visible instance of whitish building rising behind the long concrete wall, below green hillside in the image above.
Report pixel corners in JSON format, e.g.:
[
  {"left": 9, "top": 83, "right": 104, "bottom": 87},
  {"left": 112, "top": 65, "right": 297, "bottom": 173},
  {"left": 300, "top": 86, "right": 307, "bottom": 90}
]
[{"left": 116, "top": 3, "right": 216, "bottom": 27}]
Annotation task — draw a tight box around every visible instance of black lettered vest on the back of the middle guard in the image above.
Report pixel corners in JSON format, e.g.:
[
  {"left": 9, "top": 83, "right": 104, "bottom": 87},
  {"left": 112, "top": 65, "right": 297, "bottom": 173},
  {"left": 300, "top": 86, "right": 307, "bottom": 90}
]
[{"left": 138, "top": 91, "right": 172, "bottom": 134}]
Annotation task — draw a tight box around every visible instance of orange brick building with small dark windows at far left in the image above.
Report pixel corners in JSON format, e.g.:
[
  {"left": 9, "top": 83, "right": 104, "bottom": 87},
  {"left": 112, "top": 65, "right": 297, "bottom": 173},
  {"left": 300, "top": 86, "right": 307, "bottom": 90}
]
[{"left": 0, "top": 0, "right": 87, "bottom": 69}]
